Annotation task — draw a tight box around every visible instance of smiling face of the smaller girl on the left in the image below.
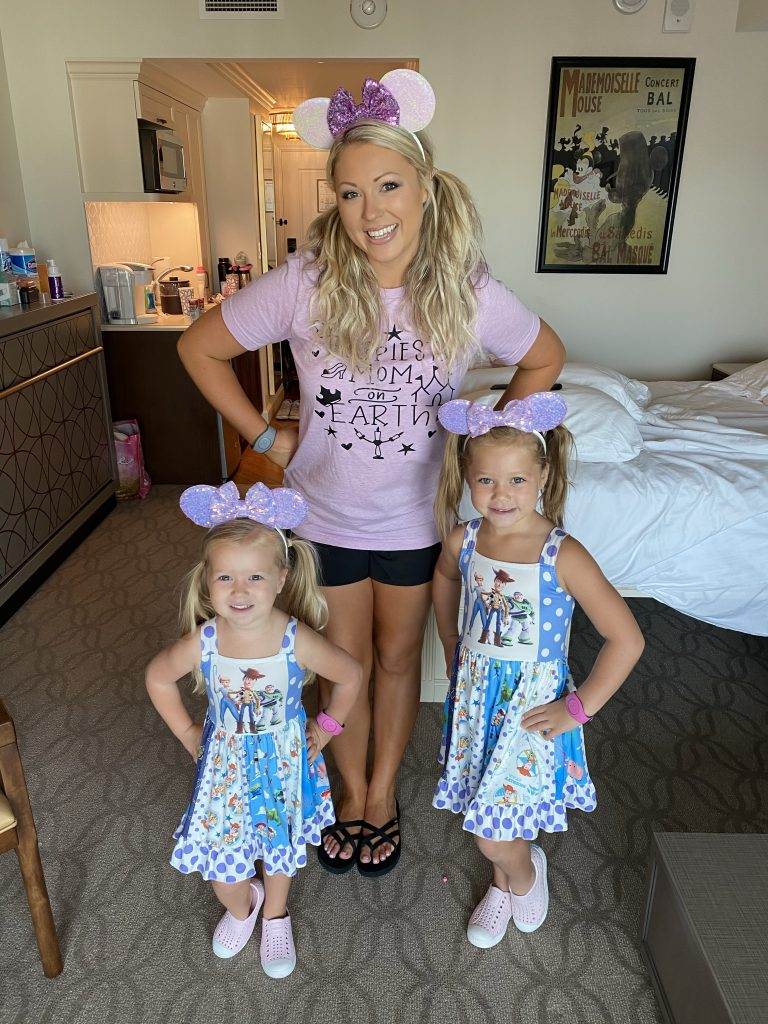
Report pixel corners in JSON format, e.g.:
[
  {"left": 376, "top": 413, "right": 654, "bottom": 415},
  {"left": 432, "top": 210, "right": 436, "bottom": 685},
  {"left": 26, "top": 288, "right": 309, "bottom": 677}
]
[{"left": 208, "top": 539, "right": 287, "bottom": 628}]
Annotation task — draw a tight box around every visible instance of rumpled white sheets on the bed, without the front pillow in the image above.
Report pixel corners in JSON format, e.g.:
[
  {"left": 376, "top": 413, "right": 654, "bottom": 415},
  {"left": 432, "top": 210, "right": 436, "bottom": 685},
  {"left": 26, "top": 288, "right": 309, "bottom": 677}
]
[{"left": 460, "top": 368, "right": 768, "bottom": 636}]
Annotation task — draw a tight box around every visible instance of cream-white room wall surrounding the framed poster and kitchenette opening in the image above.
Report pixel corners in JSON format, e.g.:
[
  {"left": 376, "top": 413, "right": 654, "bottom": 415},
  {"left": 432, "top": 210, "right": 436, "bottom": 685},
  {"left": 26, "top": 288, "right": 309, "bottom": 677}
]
[{"left": 0, "top": 0, "right": 768, "bottom": 377}]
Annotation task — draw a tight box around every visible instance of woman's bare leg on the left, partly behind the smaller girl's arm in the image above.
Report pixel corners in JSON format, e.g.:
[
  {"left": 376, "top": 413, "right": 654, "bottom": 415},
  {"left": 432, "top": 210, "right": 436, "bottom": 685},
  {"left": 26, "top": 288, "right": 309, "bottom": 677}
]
[{"left": 318, "top": 580, "right": 374, "bottom": 860}]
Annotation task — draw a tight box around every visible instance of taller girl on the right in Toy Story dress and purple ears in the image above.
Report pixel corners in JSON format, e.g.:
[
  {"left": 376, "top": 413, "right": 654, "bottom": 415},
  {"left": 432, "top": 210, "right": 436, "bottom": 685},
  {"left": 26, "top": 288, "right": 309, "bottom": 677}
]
[{"left": 433, "top": 392, "right": 643, "bottom": 948}]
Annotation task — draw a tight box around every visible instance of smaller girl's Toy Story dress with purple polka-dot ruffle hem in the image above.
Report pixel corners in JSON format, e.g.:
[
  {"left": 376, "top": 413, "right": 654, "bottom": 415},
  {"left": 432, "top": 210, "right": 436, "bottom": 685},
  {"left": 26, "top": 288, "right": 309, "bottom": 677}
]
[{"left": 171, "top": 618, "right": 335, "bottom": 883}]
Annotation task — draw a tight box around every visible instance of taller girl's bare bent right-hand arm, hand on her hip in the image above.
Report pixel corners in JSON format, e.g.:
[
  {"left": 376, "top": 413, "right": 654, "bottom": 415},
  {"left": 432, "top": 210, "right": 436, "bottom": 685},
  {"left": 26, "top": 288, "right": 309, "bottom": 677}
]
[{"left": 522, "top": 537, "right": 645, "bottom": 736}]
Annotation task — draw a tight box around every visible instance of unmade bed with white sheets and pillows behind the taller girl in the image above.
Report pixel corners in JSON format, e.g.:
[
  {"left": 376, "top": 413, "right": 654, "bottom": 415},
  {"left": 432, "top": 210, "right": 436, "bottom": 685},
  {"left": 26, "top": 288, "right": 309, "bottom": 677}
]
[{"left": 422, "top": 359, "right": 768, "bottom": 699}]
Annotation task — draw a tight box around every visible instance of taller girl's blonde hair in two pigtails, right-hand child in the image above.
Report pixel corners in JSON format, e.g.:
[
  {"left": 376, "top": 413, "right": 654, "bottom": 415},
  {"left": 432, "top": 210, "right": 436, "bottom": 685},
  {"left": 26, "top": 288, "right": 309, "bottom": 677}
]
[{"left": 434, "top": 425, "right": 573, "bottom": 540}]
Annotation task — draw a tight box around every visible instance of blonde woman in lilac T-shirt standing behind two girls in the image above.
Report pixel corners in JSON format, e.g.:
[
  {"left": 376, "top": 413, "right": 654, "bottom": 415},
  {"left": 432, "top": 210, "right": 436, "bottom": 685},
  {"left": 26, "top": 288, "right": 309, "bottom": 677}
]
[{"left": 179, "top": 71, "right": 563, "bottom": 876}]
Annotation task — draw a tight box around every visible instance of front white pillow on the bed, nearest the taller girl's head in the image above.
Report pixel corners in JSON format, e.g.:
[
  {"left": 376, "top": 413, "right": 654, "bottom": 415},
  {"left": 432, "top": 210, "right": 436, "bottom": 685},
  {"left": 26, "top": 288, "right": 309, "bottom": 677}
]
[{"left": 462, "top": 382, "right": 643, "bottom": 462}]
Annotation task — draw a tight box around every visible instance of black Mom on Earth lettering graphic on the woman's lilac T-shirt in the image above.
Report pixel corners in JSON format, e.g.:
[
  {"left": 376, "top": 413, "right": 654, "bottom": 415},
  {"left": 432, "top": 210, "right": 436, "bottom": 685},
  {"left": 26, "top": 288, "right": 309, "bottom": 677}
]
[{"left": 312, "top": 324, "right": 461, "bottom": 461}]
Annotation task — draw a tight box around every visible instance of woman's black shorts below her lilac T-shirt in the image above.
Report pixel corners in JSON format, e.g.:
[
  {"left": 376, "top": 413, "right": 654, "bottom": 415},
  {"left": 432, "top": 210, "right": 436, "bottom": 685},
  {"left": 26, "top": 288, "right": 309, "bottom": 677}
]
[{"left": 313, "top": 541, "right": 440, "bottom": 587}]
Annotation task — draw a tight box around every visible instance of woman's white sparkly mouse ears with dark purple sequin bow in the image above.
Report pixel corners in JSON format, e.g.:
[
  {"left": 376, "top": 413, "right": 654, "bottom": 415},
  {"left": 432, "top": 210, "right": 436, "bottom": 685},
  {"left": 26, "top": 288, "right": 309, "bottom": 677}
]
[{"left": 293, "top": 68, "right": 435, "bottom": 150}]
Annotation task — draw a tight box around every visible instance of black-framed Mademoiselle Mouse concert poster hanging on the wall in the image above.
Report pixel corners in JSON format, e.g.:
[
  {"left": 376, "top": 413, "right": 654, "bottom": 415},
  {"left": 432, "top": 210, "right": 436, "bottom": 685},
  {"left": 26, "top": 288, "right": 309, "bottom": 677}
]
[{"left": 537, "top": 57, "right": 696, "bottom": 273}]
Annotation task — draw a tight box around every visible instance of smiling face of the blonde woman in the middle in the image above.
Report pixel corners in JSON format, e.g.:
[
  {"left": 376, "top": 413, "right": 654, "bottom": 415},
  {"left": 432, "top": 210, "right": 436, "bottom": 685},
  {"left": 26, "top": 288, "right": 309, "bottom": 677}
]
[{"left": 334, "top": 142, "right": 428, "bottom": 288}]
